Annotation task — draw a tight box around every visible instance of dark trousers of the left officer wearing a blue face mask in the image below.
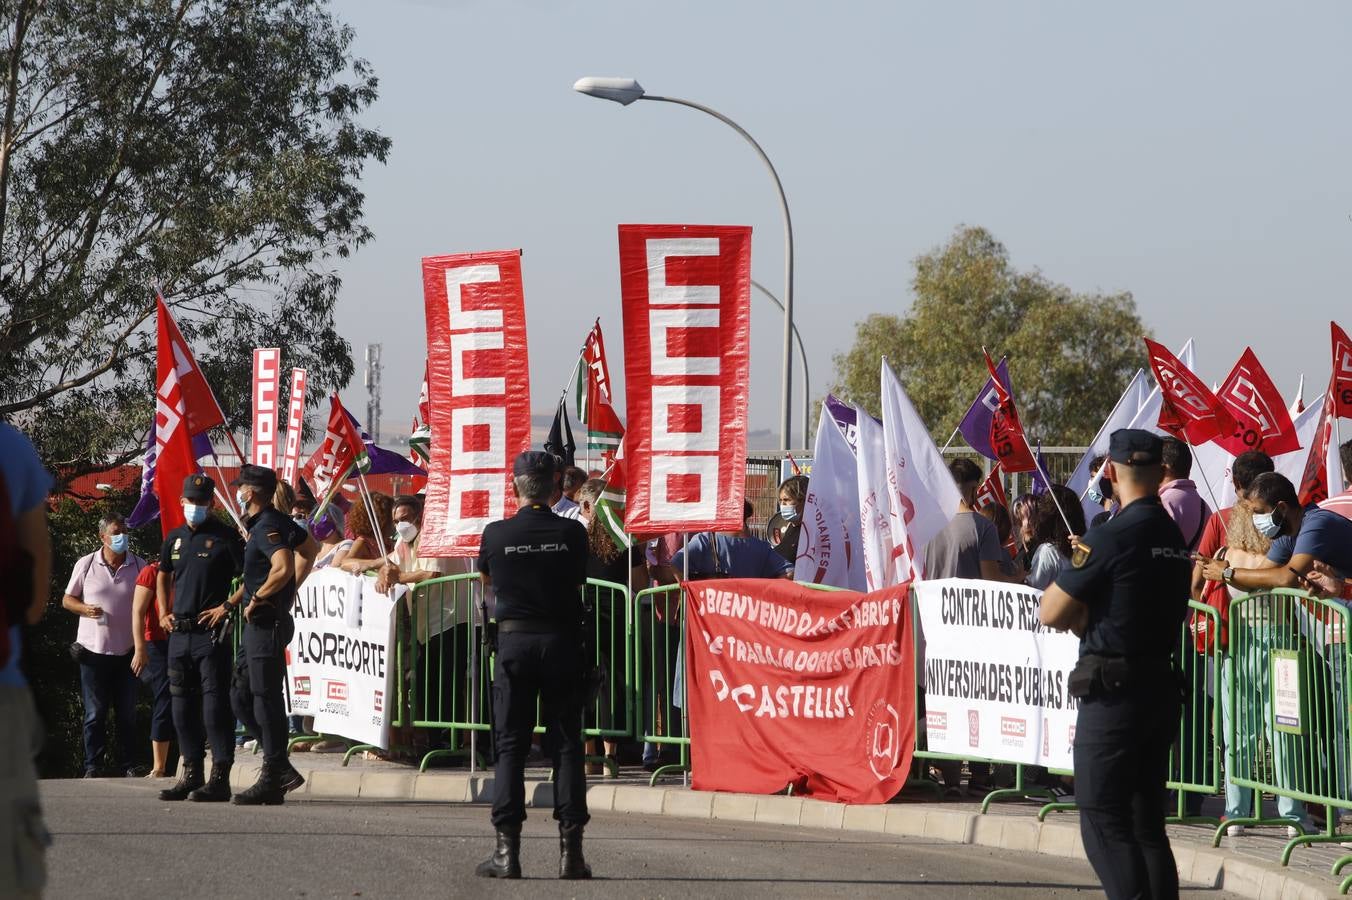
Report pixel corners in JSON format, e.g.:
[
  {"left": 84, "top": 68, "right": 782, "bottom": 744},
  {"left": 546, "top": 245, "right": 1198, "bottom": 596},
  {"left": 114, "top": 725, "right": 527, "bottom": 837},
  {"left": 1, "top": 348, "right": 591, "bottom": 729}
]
[{"left": 169, "top": 632, "right": 235, "bottom": 764}]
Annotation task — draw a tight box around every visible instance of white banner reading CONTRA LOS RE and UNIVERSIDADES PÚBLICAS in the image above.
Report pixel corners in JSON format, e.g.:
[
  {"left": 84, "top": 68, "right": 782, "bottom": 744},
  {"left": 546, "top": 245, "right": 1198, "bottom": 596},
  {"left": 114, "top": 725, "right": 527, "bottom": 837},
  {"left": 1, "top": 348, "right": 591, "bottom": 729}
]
[{"left": 914, "top": 578, "right": 1080, "bottom": 770}]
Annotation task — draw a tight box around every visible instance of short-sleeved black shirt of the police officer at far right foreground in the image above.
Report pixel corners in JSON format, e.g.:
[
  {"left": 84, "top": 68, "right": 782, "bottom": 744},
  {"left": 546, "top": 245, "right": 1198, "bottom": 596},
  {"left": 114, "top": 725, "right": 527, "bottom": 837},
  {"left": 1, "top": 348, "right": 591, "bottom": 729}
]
[{"left": 1056, "top": 497, "right": 1192, "bottom": 658}]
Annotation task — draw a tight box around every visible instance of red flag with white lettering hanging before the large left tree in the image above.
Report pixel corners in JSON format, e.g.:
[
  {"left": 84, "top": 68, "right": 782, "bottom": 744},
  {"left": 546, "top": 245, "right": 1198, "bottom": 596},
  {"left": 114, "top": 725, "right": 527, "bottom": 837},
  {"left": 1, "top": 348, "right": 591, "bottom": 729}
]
[{"left": 154, "top": 300, "right": 206, "bottom": 536}]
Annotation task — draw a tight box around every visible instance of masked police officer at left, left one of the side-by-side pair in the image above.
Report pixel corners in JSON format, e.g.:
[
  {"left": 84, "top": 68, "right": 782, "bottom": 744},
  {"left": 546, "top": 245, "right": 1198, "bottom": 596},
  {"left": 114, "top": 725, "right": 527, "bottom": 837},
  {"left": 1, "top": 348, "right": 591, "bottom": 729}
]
[{"left": 155, "top": 474, "right": 243, "bottom": 803}]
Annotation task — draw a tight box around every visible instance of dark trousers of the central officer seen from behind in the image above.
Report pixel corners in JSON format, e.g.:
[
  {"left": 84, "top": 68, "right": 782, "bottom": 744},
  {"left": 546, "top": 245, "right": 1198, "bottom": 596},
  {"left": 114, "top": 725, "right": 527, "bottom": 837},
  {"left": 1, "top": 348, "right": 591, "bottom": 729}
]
[{"left": 492, "top": 631, "right": 591, "bottom": 828}]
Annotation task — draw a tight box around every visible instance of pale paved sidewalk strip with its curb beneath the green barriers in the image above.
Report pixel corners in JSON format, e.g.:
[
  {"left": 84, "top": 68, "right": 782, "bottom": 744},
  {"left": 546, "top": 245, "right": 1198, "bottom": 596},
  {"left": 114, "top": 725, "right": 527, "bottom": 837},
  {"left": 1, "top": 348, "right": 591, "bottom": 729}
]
[{"left": 231, "top": 753, "right": 1352, "bottom": 900}]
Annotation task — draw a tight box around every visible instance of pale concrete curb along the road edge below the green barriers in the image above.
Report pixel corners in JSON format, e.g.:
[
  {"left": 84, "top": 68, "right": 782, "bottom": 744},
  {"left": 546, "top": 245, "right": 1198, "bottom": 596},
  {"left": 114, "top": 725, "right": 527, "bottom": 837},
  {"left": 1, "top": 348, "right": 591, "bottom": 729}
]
[{"left": 230, "top": 759, "right": 1337, "bottom": 900}]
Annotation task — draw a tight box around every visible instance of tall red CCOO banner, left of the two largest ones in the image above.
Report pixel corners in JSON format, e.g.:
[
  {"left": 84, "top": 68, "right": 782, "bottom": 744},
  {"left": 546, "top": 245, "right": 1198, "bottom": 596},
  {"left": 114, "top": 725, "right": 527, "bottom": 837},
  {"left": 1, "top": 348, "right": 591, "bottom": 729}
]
[{"left": 418, "top": 250, "right": 530, "bottom": 557}]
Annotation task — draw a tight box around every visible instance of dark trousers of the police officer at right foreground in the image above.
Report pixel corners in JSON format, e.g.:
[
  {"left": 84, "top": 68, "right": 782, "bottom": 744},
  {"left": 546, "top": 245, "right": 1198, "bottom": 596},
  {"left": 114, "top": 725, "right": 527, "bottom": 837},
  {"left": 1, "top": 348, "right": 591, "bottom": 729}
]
[{"left": 1075, "top": 685, "right": 1179, "bottom": 900}]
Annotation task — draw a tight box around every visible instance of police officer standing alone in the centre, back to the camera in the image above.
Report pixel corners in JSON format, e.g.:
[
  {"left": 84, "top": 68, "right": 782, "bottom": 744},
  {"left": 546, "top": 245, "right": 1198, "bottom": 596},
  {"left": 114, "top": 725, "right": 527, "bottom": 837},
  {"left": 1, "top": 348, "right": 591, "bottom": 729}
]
[{"left": 475, "top": 450, "right": 591, "bottom": 878}]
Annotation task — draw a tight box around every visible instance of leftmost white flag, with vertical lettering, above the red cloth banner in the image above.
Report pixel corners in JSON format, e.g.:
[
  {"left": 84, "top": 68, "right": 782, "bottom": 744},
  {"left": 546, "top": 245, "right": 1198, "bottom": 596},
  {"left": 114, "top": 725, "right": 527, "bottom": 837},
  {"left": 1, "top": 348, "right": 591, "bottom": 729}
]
[{"left": 794, "top": 403, "right": 868, "bottom": 591}]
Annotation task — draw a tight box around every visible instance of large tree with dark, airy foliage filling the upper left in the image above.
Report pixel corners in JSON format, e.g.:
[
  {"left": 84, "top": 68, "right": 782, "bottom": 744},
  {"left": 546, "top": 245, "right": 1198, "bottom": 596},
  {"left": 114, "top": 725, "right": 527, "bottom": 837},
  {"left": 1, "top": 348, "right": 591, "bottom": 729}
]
[{"left": 0, "top": 0, "right": 389, "bottom": 478}]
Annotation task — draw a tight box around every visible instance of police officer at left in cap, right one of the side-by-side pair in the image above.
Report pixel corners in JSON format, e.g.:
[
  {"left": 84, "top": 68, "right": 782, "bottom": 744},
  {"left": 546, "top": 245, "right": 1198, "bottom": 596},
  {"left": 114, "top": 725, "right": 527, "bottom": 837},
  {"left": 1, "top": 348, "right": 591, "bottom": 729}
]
[{"left": 230, "top": 465, "right": 314, "bottom": 805}]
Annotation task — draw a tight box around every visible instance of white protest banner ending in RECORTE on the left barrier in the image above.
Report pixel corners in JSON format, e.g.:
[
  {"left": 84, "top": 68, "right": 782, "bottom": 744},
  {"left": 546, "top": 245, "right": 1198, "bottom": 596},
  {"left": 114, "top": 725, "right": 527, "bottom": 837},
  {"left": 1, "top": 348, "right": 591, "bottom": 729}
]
[{"left": 287, "top": 569, "right": 407, "bottom": 749}]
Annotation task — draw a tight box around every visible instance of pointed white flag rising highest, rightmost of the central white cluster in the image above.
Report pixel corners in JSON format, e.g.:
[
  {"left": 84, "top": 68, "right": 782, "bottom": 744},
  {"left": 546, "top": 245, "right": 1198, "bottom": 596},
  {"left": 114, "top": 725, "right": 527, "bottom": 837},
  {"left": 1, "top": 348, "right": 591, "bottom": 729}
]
[{"left": 880, "top": 359, "right": 963, "bottom": 584}]
